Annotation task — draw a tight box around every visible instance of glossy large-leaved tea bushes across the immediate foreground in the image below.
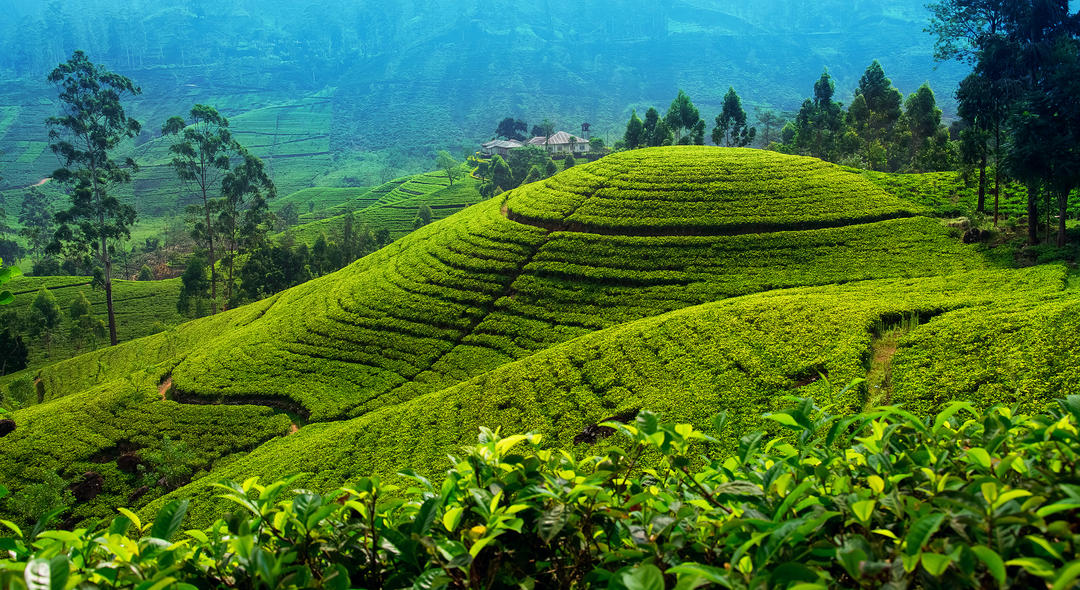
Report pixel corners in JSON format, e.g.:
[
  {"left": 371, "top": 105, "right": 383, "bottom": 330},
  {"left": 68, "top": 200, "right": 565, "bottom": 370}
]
[{"left": 0, "top": 395, "right": 1080, "bottom": 590}]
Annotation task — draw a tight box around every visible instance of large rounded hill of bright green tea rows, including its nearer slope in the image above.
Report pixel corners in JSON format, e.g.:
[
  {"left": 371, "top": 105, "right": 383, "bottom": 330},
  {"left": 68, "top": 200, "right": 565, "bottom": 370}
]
[{"left": 0, "top": 147, "right": 1078, "bottom": 523}]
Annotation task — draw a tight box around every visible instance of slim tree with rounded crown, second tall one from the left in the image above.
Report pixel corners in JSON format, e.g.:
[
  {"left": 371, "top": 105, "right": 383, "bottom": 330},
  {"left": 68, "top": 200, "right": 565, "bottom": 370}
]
[{"left": 161, "top": 105, "right": 240, "bottom": 313}]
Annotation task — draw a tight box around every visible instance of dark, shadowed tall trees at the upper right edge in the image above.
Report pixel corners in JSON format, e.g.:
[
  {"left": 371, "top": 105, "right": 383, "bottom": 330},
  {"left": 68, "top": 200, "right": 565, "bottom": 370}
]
[{"left": 930, "top": 0, "right": 1080, "bottom": 245}]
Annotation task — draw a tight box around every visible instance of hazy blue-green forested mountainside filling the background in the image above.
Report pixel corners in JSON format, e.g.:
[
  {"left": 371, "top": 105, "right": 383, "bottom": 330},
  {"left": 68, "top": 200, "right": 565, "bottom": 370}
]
[{"left": 0, "top": 0, "right": 961, "bottom": 190}]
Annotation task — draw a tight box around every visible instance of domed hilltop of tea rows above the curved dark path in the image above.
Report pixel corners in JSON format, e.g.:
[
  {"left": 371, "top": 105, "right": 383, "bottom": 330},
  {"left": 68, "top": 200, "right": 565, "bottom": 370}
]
[{"left": 508, "top": 147, "right": 920, "bottom": 234}]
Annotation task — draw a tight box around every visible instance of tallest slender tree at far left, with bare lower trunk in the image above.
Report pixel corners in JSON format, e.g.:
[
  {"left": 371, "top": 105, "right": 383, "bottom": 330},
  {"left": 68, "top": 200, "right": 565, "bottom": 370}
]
[{"left": 45, "top": 51, "right": 141, "bottom": 345}]
